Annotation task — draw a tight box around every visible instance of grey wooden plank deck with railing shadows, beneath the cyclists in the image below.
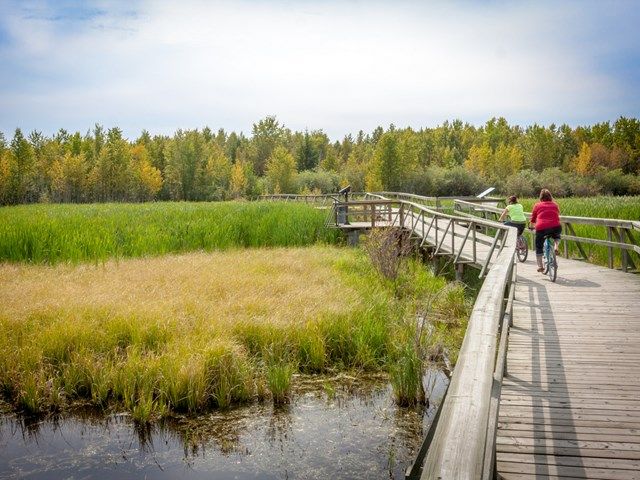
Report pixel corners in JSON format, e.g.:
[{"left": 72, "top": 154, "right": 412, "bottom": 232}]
[{"left": 496, "top": 252, "right": 640, "bottom": 479}]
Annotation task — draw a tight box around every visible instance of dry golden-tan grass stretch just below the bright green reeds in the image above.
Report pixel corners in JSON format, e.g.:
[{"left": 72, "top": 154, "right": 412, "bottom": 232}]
[{"left": 0, "top": 247, "right": 362, "bottom": 329}]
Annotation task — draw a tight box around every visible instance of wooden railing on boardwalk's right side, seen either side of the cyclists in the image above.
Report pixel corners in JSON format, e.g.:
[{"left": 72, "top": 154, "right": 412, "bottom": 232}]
[{"left": 454, "top": 200, "right": 640, "bottom": 272}]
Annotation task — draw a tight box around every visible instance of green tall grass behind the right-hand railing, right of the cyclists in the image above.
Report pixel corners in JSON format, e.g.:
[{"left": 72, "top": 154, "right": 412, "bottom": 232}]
[{"left": 521, "top": 196, "right": 640, "bottom": 267}]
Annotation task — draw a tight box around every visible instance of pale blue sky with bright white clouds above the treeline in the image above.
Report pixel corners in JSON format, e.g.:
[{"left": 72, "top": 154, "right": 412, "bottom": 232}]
[{"left": 0, "top": 0, "right": 640, "bottom": 140}]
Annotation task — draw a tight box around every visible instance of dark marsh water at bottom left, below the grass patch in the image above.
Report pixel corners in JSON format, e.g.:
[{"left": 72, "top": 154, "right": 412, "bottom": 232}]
[{"left": 0, "top": 371, "right": 447, "bottom": 480}]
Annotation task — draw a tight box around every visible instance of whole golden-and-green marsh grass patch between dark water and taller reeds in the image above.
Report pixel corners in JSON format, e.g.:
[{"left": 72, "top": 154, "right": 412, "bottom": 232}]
[{"left": 0, "top": 246, "right": 466, "bottom": 422}]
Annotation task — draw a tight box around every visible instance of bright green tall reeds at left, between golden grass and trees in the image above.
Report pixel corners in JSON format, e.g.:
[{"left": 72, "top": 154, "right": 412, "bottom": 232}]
[{"left": 0, "top": 202, "right": 337, "bottom": 264}]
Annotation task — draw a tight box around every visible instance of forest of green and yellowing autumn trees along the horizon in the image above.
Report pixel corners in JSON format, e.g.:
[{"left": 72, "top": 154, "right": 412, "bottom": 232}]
[{"left": 0, "top": 116, "right": 640, "bottom": 205}]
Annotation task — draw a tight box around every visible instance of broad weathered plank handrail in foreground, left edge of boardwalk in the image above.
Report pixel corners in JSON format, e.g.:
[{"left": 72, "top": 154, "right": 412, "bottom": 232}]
[{"left": 422, "top": 230, "right": 517, "bottom": 479}]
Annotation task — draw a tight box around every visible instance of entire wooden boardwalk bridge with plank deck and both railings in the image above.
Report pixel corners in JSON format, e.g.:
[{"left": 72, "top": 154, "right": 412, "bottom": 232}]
[{"left": 264, "top": 193, "right": 640, "bottom": 480}]
